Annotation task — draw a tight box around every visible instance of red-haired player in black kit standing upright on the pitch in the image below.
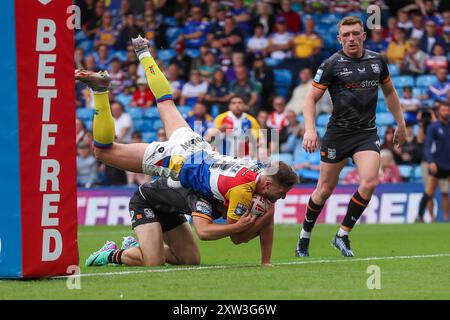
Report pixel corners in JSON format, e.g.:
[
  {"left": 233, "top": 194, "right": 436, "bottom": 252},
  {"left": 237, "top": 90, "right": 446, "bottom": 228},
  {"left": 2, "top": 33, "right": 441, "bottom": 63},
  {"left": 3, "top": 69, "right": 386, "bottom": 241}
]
[{"left": 296, "top": 16, "right": 406, "bottom": 257}]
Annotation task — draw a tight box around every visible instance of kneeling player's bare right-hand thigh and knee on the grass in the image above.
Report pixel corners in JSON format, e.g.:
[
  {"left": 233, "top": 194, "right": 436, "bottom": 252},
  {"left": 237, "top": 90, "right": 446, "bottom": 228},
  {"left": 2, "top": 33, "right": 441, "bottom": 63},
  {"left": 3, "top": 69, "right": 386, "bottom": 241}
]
[{"left": 163, "top": 220, "right": 200, "bottom": 265}]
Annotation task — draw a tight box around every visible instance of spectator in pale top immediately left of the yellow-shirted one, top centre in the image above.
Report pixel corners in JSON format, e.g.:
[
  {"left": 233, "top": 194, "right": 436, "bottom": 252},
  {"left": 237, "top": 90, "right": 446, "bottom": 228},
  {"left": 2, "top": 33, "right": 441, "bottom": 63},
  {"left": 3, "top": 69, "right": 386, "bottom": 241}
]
[{"left": 266, "top": 17, "right": 294, "bottom": 60}]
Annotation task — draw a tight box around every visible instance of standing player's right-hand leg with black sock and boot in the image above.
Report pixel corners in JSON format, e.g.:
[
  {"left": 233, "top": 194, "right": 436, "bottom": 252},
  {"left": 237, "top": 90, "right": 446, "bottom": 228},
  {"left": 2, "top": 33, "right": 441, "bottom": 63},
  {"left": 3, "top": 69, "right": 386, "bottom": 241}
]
[{"left": 332, "top": 150, "right": 380, "bottom": 257}]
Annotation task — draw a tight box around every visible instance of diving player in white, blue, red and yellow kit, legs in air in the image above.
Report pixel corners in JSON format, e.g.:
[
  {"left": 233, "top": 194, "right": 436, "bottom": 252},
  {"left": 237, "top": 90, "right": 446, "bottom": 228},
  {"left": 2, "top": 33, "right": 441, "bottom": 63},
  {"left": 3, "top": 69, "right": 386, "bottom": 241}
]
[{"left": 75, "top": 37, "right": 298, "bottom": 264}]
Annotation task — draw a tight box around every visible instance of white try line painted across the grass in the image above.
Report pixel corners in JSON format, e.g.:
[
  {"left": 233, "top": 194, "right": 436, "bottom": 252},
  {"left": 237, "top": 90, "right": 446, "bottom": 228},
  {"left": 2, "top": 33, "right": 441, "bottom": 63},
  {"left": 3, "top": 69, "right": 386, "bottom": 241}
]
[{"left": 51, "top": 253, "right": 450, "bottom": 279}]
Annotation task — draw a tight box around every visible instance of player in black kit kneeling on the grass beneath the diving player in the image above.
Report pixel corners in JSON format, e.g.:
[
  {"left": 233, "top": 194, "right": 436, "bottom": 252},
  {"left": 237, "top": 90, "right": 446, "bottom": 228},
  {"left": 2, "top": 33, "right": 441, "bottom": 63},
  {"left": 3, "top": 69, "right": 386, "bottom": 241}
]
[{"left": 86, "top": 178, "right": 273, "bottom": 266}]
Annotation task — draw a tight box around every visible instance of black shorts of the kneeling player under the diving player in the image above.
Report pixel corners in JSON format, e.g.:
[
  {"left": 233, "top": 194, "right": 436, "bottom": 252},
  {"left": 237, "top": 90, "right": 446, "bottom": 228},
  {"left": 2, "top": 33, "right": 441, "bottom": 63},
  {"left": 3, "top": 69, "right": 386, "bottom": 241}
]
[{"left": 129, "top": 190, "right": 187, "bottom": 232}]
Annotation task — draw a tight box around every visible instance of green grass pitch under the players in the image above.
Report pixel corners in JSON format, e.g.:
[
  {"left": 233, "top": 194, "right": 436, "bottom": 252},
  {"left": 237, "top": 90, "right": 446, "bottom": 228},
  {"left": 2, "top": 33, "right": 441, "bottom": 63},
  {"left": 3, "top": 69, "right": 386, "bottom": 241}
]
[{"left": 0, "top": 224, "right": 450, "bottom": 300}]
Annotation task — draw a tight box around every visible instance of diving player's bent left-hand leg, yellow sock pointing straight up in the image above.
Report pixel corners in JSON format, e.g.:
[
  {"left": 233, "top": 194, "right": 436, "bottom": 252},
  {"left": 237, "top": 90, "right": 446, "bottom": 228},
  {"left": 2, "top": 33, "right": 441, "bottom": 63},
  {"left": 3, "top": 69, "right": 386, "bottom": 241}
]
[{"left": 75, "top": 70, "right": 148, "bottom": 172}]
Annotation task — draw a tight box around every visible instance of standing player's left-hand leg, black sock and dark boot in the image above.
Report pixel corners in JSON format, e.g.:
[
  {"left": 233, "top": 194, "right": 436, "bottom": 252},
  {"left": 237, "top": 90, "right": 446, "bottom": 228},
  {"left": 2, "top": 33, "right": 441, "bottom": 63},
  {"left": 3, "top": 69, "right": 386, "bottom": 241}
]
[{"left": 295, "top": 159, "right": 347, "bottom": 257}]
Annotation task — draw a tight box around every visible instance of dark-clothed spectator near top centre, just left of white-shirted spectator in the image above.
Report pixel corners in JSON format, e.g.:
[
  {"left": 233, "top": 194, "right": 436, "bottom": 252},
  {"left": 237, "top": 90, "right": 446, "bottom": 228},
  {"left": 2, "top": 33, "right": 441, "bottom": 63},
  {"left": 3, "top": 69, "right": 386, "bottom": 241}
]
[{"left": 212, "top": 17, "right": 245, "bottom": 52}]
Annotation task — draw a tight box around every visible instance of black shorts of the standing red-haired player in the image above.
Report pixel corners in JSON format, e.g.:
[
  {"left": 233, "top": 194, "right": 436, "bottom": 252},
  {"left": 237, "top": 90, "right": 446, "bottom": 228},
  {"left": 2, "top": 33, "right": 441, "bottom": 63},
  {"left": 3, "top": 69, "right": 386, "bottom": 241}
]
[{"left": 320, "top": 130, "right": 380, "bottom": 163}]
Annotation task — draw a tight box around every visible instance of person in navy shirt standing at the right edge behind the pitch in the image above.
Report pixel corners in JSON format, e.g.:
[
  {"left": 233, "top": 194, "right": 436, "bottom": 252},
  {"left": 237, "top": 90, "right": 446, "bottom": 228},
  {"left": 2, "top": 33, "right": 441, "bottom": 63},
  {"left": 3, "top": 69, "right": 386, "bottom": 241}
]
[{"left": 418, "top": 101, "right": 450, "bottom": 221}]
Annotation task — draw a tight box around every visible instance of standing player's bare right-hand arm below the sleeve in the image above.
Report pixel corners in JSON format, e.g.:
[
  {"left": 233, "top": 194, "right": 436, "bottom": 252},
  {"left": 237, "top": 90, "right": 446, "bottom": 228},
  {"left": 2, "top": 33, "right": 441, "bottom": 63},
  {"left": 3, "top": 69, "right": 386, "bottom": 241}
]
[{"left": 381, "top": 80, "right": 406, "bottom": 146}]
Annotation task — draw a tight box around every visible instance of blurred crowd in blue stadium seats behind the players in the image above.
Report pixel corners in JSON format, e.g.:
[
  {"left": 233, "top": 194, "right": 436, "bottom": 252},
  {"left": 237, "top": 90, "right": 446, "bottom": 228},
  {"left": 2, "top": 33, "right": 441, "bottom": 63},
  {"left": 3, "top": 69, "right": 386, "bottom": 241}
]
[{"left": 75, "top": 0, "right": 450, "bottom": 190}]
